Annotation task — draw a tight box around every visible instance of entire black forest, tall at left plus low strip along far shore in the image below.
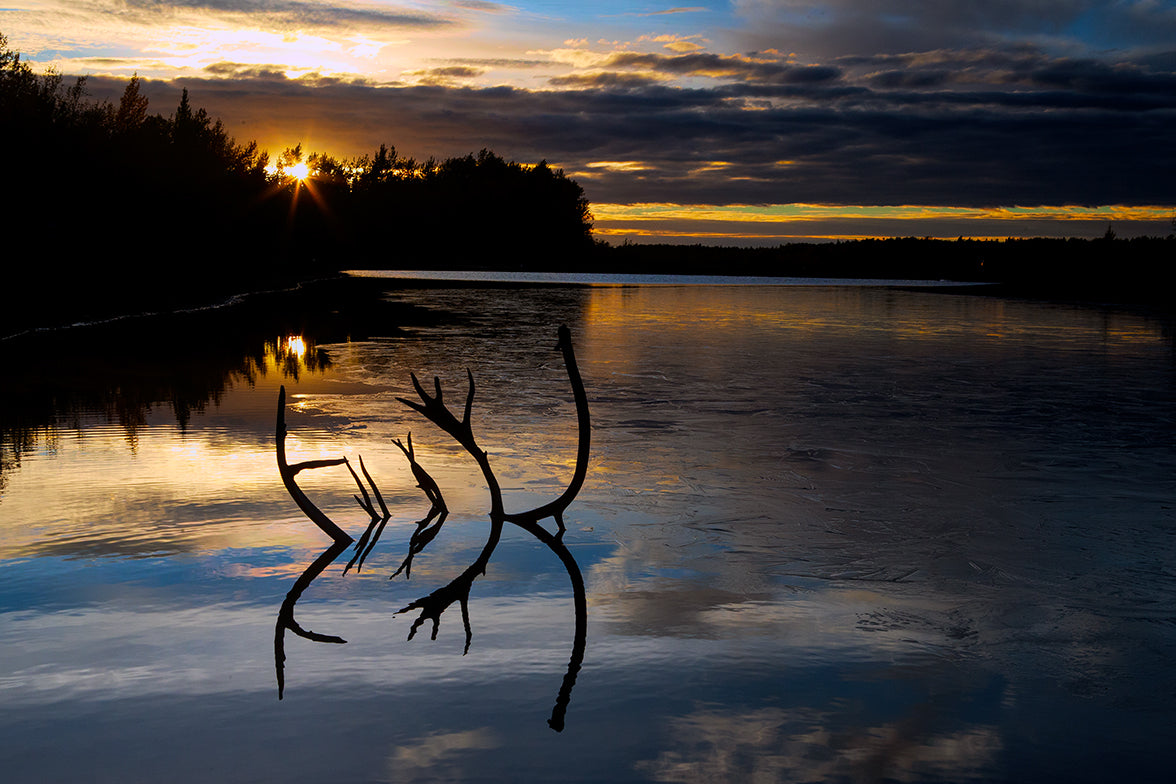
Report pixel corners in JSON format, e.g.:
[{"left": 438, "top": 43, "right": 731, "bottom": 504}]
[{"left": 0, "top": 35, "right": 1176, "bottom": 334}]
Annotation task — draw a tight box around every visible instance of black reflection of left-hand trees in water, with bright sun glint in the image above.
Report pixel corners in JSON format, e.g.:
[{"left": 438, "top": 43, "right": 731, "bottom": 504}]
[{"left": 0, "top": 280, "right": 435, "bottom": 488}]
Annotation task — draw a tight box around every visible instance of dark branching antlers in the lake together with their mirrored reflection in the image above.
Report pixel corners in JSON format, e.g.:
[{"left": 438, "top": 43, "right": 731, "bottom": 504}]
[{"left": 274, "top": 327, "right": 592, "bottom": 732}]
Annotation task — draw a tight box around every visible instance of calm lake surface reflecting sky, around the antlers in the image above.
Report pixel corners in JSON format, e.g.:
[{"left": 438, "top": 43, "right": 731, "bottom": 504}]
[{"left": 0, "top": 282, "right": 1176, "bottom": 783}]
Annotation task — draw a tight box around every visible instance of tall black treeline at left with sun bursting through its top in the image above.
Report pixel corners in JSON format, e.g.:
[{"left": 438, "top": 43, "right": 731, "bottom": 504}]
[{"left": 0, "top": 35, "right": 592, "bottom": 334}]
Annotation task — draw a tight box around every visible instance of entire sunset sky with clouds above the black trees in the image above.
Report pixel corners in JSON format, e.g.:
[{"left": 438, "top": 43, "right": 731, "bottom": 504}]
[{"left": 0, "top": 0, "right": 1176, "bottom": 244}]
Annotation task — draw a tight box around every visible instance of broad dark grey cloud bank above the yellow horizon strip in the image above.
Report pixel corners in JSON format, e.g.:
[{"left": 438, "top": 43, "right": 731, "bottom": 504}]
[{"left": 78, "top": 40, "right": 1176, "bottom": 207}]
